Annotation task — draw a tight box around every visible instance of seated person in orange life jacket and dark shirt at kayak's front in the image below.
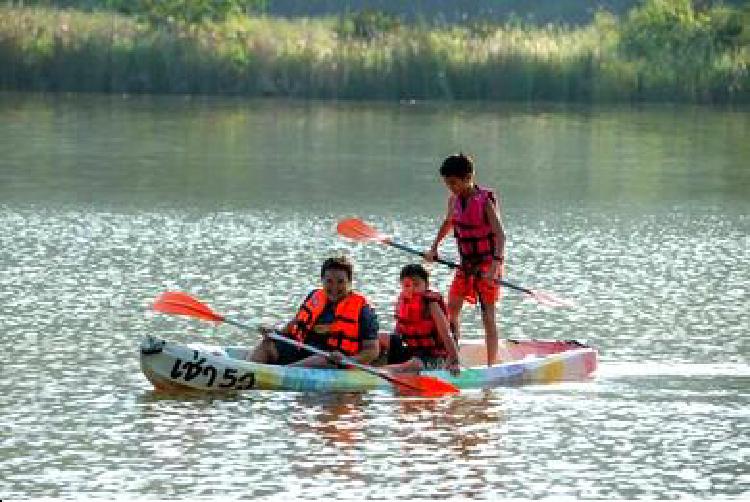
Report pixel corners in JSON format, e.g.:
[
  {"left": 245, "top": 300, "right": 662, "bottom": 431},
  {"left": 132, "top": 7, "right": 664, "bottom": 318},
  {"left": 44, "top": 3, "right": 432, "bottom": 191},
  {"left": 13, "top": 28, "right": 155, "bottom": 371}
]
[{"left": 248, "top": 256, "right": 380, "bottom": 368}]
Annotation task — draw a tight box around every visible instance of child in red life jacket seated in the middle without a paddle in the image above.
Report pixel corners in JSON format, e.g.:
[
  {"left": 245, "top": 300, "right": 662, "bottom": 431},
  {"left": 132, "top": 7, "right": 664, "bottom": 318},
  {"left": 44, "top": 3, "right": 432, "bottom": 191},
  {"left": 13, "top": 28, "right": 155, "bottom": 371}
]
[{"left": 381, "top": 264, "right": 459, "bottom": 374}]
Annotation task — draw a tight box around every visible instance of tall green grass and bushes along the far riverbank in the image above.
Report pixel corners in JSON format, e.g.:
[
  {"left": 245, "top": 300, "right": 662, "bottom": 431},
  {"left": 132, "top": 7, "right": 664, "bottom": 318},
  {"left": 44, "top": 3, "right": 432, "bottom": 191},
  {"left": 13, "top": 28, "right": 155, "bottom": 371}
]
[{"left": 0, "top": 0, "right": 750, "bottom": 103}]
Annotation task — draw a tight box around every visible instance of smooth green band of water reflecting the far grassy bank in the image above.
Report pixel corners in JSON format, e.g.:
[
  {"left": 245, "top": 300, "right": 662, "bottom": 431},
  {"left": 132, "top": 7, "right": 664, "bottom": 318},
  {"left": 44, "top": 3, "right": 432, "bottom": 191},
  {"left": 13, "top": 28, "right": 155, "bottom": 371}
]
[{"left": 0, "top": 93, "right": 750, "bottom": 214}]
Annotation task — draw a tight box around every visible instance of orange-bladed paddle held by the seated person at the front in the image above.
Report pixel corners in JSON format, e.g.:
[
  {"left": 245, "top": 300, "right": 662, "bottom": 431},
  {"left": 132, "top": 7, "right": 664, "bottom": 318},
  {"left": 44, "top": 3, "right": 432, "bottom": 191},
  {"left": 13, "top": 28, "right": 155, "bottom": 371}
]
[{"left": 153, "top": 291, "right": 459, "bottom": 397}]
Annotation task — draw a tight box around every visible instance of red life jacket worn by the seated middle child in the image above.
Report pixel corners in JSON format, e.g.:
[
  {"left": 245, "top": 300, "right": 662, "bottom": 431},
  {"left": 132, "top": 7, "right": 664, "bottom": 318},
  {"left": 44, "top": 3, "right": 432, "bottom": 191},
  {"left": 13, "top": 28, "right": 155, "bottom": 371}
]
[{"left": 395, "top": 291, "right": 448, "bottom": 357}]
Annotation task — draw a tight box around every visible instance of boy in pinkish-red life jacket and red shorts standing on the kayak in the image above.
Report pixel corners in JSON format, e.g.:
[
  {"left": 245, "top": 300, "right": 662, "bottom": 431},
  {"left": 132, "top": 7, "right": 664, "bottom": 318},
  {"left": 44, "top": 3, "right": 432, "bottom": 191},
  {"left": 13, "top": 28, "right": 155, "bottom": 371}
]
[{"left": 424, "top": 153, "right": 505, "bottom": 366}]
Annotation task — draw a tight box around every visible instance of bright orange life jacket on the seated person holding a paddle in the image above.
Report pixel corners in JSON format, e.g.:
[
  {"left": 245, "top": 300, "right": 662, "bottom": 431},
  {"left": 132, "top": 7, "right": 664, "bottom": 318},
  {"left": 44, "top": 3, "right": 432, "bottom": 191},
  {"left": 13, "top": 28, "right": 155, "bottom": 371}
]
[{"left": 291, "top": 289, "right": 367, "bottom": 356}]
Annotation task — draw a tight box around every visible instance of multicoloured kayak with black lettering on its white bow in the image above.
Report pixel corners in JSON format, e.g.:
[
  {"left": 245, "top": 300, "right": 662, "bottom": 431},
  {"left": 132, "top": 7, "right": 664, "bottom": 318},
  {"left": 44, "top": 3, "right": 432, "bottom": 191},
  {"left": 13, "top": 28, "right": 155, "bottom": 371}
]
[{"left": 140, "top": 336, "right": 597, "bottom": 393}]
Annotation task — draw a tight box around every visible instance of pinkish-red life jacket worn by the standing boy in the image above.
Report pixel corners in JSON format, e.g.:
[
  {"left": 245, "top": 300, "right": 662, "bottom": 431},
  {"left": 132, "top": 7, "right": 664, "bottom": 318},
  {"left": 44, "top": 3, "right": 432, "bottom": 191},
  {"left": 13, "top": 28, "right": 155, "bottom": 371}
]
[{"left": 453, "top": 185, "right": 497, "bottom": 266}]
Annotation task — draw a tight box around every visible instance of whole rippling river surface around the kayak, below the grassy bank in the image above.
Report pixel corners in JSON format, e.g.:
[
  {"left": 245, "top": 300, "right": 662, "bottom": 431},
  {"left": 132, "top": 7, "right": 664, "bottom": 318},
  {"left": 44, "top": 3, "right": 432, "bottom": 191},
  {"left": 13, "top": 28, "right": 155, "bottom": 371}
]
[{"left": 0, "top": 94, "right": 750, "bottom": 499}]
